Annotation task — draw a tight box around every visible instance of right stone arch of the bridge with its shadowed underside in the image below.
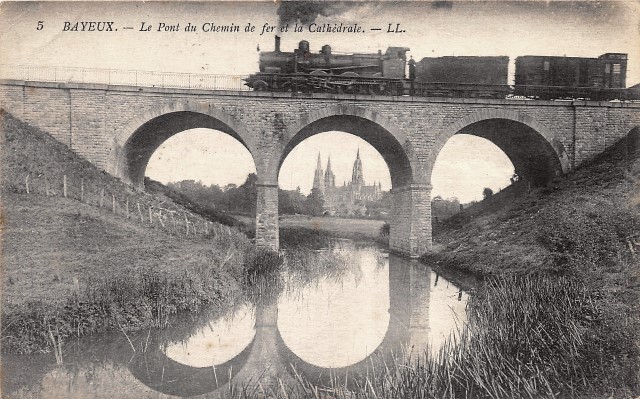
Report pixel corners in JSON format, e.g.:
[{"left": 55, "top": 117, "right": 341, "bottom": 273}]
[{"left": 427, "top": 109, "right": 571, "bottom": 185}]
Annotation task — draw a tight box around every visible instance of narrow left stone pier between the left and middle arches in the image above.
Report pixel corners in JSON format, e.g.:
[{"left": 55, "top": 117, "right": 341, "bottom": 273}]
[{"left": 256, "top": 183, "right": 280, "bottom": 251}]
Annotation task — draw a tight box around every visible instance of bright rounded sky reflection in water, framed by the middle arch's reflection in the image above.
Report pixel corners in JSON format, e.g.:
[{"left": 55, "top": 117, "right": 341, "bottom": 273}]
[{"left": 277, "top": 250, "right": 389, "bottom": 367}]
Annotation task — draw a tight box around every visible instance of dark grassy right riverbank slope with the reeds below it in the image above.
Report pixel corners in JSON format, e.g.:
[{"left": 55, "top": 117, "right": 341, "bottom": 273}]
[{"left": 422, "top": 133, "right": 640, "bottom": 397}]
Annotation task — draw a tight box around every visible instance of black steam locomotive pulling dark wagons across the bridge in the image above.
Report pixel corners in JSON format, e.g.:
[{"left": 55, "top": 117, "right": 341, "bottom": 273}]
[{"left": 245, "top": 36, "right": 640, "bottom": 101}]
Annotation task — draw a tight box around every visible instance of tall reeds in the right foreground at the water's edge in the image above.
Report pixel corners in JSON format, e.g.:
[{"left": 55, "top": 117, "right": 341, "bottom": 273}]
[{"left": 226, "top": 275, "right": 637, "bottom": 399}]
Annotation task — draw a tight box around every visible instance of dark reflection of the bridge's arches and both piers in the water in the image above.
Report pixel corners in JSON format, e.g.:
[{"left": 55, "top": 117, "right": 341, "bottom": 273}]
[{"left": 129, "top": 255, "right": 452, "bottom": 396}]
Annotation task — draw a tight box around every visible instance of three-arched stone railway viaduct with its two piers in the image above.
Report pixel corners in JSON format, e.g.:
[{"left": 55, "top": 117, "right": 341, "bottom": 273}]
[{"left": 0, "top": 80, "right": 640, "bottom": 256}]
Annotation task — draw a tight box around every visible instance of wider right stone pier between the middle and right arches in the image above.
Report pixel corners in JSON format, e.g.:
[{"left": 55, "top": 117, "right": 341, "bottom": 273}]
[{"left": 389, "top": 183, "right": 432, "bottom": 258}]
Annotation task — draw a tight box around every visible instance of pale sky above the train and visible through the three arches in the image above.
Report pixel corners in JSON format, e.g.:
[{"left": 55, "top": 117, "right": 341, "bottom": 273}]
[{"left": 0, "top": 0, "right": 640, "bottom": 202}]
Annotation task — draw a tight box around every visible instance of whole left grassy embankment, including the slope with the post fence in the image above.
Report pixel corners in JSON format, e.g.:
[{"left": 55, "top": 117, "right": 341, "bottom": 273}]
[{"left": 2, "top": 113, "right": 278, "bottom": 353}]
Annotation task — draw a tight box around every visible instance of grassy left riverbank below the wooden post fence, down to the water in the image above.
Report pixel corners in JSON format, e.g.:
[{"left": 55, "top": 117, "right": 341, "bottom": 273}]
[{"left": 2, "top": 193, "right": 258, "bottom": 353}]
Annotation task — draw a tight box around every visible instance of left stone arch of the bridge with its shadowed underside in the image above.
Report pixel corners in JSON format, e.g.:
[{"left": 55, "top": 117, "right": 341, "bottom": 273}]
[{"left": 110, "top": 101, "right": 262, "bottom": 188}]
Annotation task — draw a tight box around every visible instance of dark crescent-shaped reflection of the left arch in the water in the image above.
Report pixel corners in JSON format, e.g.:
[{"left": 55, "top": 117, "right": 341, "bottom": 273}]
[{"left": 128, "top": 335, "right": 253, "bottom": 397}]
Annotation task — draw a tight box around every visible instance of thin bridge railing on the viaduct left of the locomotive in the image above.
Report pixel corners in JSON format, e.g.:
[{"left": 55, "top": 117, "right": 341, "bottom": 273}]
[{"left": 0, "top": 65, "right": 251, "bottom": 91}]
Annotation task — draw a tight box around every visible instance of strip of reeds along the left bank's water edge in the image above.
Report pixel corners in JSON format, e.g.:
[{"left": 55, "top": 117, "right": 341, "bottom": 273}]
[{"left": 2, "top": 254, "right": 245, "bottom": 354}]
